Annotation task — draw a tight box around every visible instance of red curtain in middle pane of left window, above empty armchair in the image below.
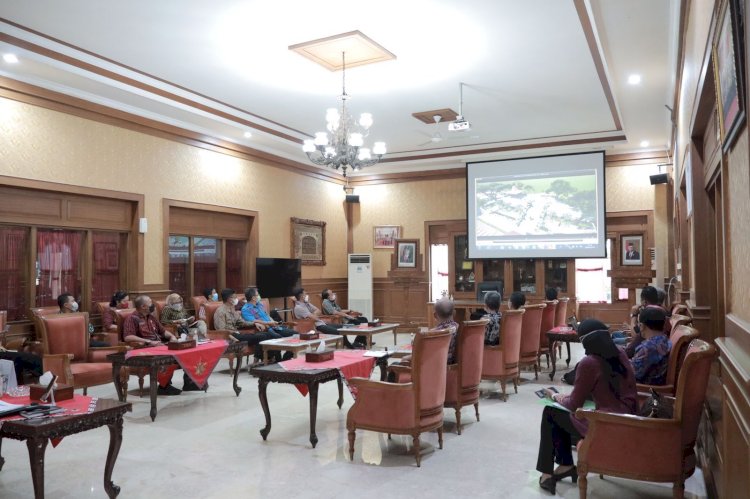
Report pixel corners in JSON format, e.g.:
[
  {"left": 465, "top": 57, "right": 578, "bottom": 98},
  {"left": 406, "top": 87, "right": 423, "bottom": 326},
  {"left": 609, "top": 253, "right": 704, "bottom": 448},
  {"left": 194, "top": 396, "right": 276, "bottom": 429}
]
[{"left": 36, "top": 230, "right": 83, "bottom": 307}]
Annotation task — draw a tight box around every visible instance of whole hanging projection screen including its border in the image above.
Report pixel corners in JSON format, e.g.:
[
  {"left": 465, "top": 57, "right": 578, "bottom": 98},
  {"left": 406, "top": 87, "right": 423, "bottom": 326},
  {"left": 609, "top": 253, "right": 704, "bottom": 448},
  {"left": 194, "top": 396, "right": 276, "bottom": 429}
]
[{"left": 466, "top": 151, "right": 607, "bottom": 259}]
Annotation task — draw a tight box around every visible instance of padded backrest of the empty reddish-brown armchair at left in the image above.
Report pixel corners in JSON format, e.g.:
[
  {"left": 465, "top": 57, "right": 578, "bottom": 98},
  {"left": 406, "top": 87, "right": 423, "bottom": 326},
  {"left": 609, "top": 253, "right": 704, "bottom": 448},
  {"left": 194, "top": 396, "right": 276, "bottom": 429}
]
[{"left": 41, "top": 312, "right": 89, "bottom": 362}]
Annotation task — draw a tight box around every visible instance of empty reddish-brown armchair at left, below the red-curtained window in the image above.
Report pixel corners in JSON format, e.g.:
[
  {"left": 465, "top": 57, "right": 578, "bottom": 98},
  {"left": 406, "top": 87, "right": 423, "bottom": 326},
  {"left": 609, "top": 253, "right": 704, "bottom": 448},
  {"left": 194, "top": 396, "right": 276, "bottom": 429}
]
[{"left": 40, "top": 312, "right": 127, "bottom": 395}]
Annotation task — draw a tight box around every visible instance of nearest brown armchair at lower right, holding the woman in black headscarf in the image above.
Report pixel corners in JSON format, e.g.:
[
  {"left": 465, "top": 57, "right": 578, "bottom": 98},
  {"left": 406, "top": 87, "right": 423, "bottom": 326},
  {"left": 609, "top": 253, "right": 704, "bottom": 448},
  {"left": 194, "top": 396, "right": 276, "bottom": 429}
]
[{"left": 576, "top": 340, "right": 716, "bottom": 499}]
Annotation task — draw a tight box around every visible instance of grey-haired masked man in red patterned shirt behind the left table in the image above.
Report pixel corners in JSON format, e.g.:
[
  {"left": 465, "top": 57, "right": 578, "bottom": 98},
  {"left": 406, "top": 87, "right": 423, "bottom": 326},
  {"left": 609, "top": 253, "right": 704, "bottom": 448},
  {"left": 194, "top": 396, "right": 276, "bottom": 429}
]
[{"left": 122, "top": 295, "right": 199, "bottom": 395}]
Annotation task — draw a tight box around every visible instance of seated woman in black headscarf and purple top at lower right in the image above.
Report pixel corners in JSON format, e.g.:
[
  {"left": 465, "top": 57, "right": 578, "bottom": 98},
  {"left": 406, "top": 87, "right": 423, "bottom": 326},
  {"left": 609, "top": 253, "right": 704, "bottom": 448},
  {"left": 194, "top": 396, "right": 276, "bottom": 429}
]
[{"left": 536, "top": 319, "right": 638, "bottom": 494}]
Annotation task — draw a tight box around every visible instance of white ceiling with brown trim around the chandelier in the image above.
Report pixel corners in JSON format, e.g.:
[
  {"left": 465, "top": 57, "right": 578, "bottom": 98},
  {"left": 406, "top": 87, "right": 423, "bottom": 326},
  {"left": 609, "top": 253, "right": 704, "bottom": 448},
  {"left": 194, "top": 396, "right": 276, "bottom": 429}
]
[{"left": 0, "top": 0, "right": 679, "bottom": 173}]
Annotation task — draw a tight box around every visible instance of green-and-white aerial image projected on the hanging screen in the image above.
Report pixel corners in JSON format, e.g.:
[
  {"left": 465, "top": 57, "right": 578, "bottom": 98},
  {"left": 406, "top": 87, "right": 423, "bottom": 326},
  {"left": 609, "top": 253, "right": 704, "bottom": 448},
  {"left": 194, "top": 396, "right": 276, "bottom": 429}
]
[{"left": 476, "top": 170, "right": 597, "bottom": 239}]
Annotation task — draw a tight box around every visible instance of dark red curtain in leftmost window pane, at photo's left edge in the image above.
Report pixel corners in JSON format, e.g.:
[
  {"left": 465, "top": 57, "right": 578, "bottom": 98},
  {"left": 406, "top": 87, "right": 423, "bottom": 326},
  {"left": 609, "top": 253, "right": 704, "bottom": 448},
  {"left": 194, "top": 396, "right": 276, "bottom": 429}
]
[{"left": 0, "top": 227, "right": 29, "bottom": 321}]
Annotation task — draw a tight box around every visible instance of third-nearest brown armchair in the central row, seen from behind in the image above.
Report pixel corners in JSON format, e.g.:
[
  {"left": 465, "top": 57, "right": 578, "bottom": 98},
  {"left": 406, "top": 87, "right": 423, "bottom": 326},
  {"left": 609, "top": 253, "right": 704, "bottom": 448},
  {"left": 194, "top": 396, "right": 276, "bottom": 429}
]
[{"left": 482, "top": 309, "right": 526, "bottom": 401}]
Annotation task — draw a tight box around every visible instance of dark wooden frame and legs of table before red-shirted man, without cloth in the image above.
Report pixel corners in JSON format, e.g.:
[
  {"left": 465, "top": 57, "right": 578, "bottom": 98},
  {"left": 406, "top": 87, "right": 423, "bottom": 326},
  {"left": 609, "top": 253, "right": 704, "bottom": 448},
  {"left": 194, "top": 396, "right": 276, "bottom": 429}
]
[{"left": 107, "top": 341, "right": 247, "bottom": 421}]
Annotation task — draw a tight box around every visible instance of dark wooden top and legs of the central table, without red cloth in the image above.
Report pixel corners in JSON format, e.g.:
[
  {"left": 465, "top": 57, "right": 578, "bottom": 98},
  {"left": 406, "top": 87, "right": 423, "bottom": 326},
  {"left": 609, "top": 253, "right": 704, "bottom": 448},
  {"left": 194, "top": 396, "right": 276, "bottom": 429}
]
[{"left": 250, "top": 355, "right": 388, "bottom": 448}]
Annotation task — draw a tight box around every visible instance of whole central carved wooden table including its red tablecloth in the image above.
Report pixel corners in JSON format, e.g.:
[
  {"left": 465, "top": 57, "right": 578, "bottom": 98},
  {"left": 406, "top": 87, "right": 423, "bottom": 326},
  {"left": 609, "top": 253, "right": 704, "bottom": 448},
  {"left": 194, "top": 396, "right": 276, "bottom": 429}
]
[{"left": 250, "top": 350, "right": 388, "bottom": 447}]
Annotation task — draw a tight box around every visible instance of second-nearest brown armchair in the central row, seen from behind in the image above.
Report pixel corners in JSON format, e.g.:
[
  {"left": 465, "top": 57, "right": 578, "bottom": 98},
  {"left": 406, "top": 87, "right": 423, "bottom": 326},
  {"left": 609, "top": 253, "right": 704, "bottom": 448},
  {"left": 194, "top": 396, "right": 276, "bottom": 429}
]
[{"left": 443, "top": 319, "right": 487, "bottom": 435}]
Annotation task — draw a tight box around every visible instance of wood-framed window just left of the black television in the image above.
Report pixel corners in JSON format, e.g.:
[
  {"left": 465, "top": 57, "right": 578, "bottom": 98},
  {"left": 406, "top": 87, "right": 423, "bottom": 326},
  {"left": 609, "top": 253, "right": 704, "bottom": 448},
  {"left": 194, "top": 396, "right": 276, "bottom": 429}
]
[{"left": 168, "top": 235, "right": 248, "bottom": 297}]
